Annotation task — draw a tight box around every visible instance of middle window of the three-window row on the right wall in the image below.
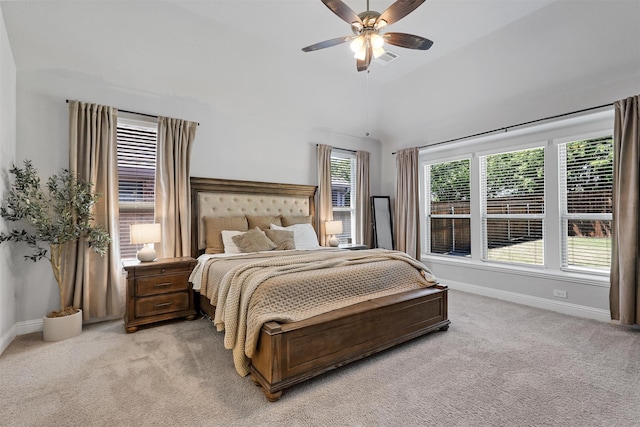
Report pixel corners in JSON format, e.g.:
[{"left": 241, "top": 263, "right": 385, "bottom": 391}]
[{"left": 480, "top": 148, "right": 545, "bottom": 265}]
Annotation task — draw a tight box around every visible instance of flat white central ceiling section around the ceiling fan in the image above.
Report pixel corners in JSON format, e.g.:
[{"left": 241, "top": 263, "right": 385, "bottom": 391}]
[{"left": 169, "top": 0, "right": 553, "bottom": 83}]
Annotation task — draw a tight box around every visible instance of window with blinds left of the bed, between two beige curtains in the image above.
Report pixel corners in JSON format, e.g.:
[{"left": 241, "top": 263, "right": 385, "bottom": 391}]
[{"left": 117, "top": 118, "right": 157, "bottom": 259}]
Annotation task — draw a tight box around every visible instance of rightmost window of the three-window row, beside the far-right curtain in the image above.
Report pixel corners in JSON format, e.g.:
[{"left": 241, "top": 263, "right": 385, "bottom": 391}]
[{"left": 558, "top": 136, "right": 613, "bottom": 271}]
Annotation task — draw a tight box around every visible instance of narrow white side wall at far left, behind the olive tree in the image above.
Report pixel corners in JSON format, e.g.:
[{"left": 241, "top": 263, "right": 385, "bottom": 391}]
[{"left": 0, "top": 5, "right": 17, "bottom": 353}]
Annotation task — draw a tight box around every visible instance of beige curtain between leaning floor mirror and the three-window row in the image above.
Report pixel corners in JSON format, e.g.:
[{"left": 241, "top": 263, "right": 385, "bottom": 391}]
[{"left": 395, "top": 147, "right": 420, "bottom": 259}]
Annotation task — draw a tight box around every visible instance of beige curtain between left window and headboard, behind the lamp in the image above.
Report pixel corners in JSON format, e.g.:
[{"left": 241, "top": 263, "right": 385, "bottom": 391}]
[{"left": 155, "top": 117, "right": 198, "bottom": 258}]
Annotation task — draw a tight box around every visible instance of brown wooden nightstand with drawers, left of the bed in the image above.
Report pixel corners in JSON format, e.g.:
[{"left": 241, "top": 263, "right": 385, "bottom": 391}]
[{"left": 123, "top": 257, "right": 196, "bottom": 333}]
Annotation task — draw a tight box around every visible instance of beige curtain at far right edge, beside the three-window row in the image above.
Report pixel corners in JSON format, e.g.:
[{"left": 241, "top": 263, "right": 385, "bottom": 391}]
[{"left": 609, "top": 95, "right": 640, "bottom": 325}]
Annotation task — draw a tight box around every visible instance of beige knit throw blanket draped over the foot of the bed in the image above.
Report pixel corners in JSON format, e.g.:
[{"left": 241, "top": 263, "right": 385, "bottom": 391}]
[{"left": 205, "top": 249, "right": 436, "bottom": 376}]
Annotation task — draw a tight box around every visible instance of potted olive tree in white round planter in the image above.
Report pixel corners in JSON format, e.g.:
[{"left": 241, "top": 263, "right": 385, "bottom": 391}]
[{"left": 0, "top": 160, "right": 110, "bottom": 341}]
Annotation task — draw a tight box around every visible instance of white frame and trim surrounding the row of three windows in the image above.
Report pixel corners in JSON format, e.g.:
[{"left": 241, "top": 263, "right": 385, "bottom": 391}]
[{"left": 419, "top": 109, "right": 614, "bottom": 287}]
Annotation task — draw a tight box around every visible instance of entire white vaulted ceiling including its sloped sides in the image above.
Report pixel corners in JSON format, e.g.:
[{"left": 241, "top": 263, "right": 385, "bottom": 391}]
[{"left": 0, "top": 0, "right": 640, "bottom": 142}]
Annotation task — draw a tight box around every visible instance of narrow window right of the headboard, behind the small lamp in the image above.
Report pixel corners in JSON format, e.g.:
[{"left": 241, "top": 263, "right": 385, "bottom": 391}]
[{"left": 331, "top": 154, "right": 356, "bottom": 243}]
